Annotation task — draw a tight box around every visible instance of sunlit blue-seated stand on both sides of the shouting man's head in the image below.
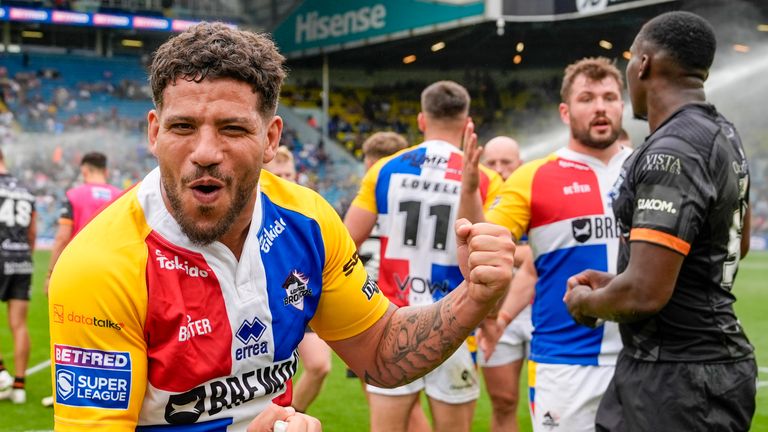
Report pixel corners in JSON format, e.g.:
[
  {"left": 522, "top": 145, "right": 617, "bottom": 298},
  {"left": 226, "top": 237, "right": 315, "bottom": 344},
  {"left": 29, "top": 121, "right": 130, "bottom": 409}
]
[{"left": 0, "top": 53, "right": 362, "bottom": 243}]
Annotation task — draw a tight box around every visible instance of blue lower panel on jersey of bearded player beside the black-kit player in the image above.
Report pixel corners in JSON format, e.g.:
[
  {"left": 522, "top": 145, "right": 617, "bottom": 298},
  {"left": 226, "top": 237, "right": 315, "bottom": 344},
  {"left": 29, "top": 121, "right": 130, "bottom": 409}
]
[{"left": 531, "top": 245, "right": 608, "bottom": 365}]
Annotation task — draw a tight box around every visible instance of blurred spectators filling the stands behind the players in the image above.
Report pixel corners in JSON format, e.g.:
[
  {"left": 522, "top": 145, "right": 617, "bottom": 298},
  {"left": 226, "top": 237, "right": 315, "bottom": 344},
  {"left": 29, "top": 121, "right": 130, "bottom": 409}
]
[{"left": 0, "top": 52, "right": 768, "bottom": 243}]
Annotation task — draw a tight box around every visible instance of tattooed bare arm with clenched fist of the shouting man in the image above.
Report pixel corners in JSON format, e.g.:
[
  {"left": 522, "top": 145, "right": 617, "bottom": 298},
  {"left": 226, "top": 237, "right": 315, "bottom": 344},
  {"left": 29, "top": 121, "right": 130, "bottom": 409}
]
[{"left": 329, "top": 220, "right": 514, "bottom": 387}]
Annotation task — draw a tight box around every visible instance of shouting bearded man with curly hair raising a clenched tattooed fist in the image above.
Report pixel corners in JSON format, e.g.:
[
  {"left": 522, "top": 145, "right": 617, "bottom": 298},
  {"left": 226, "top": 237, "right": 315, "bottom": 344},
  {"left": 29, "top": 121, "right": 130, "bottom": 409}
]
[{"left": 49, "top": 23, "right": 514, "bottom": 432}]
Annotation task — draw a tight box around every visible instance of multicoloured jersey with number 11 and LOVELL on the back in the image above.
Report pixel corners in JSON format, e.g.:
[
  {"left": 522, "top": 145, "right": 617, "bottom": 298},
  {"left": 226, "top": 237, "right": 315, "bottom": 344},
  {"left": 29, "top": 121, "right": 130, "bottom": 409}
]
[{"left": 352, "top": 140, "right": 501, "bottom": 306}]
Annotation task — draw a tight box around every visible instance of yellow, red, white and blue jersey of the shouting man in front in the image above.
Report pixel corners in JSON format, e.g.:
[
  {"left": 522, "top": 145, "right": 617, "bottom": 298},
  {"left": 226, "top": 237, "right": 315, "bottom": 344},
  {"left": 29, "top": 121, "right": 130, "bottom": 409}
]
[{"left": 49, "top": 169, "right": 389, "bottom": 431}]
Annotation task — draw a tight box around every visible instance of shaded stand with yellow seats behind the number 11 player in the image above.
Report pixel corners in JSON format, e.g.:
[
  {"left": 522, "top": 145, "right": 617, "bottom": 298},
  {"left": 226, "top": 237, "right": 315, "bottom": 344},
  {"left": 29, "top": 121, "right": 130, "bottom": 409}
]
[{"left": 281, "top": 69, "right": 559, "bottom": 160}]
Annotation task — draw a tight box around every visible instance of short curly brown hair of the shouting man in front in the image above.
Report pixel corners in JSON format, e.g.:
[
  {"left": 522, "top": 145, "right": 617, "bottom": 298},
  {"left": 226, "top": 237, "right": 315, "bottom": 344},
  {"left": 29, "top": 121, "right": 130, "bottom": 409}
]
[{"left": 149, "top": 23, "right": 286, "bottom": 115}]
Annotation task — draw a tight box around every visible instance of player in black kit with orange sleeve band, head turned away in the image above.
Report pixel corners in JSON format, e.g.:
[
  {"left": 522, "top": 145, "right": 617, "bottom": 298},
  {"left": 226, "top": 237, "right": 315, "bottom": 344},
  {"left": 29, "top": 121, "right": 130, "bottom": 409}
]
[{"left": 565, "top": 12, "right": 757, "bottom": 431}]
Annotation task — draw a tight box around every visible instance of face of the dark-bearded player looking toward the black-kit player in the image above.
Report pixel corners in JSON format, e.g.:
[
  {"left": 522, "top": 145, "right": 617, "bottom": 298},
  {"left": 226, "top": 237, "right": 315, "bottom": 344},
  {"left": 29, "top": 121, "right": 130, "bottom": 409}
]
[{"left": 560, "top": 75, "right": 624, "bottom": 149}]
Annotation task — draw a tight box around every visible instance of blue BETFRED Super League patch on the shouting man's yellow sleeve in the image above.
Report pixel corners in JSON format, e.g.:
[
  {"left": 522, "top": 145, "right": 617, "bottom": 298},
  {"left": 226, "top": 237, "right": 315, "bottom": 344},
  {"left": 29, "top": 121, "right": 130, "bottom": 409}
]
[{"left": 54, "top": 344, "right": 131, "bottom": 409}]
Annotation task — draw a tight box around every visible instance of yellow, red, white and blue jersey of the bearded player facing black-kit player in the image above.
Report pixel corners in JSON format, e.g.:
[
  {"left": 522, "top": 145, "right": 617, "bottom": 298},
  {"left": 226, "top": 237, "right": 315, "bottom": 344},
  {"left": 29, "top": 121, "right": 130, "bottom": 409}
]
[{"left": 486, "top": 148, "right": 631, "bottom": 366}]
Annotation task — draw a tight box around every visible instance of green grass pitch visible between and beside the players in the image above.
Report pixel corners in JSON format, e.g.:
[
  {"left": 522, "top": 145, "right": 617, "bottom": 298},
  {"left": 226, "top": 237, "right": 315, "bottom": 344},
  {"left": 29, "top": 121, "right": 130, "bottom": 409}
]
[{"left": 0, "top": 251, "right": 768, "bottom": 432}]
